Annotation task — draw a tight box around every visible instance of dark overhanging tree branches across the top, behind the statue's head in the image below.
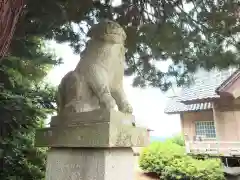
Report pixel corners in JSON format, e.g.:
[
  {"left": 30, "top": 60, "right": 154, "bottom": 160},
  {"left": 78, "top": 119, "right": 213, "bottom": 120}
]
[{"left": 11, "top": 0, "right": 240, "bottom": 90}]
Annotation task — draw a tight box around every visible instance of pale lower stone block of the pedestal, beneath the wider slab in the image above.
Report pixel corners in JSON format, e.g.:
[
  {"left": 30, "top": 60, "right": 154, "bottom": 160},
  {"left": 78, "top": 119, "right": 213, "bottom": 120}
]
[{"left": 46, "top": 148, "right": 134, "bottom": 180}]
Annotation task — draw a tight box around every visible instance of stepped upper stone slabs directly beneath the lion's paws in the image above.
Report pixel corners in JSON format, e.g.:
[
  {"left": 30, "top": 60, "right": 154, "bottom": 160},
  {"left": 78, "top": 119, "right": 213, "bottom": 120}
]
[{"left": 36, "top": 109, "right": 148, "bottom": 147}]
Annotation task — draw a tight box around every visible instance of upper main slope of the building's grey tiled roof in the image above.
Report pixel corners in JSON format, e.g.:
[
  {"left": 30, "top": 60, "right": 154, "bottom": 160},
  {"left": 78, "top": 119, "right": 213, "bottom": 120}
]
[{"left": 179, "top": 68, "right": 236, "bottom": 101}]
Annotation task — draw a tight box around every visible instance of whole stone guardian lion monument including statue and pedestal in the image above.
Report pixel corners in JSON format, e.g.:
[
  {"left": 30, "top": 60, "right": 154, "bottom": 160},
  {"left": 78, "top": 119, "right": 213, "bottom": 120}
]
[{"left": 35, "top": 21, "right": 149, "bottom": 180}]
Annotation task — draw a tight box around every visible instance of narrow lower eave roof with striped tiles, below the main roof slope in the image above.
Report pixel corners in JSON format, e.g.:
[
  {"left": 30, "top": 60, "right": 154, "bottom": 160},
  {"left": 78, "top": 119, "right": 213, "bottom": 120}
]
[{"left": 164, "top": 97, "right": 212, "bottom": 114}]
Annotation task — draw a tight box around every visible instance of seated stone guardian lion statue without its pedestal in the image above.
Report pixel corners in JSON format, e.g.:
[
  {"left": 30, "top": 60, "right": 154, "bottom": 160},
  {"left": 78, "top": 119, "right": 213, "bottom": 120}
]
[{"left": 57, "top": 21, "right": 132, "bottom": 114}]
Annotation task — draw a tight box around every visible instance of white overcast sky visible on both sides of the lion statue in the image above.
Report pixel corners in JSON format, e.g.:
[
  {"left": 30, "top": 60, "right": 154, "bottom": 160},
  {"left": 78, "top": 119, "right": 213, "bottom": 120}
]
[{"left": 46, "top": 42, "right": 181, "bottom": 137}]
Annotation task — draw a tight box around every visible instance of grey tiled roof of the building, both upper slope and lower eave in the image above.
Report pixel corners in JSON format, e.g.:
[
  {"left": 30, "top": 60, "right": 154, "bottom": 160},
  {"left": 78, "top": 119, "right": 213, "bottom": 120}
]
[{"left": 164, "top": 68, "right": 236, "bottom": 114}]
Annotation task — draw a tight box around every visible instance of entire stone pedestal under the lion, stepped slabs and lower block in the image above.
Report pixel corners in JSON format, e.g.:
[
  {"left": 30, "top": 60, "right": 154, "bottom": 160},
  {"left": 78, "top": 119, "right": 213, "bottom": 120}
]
[{"left": 35, "top": 109, "right": 149, "bottom": 180}]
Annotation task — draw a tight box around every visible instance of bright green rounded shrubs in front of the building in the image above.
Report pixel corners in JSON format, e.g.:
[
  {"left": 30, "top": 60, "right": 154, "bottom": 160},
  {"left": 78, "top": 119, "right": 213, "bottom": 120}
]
[{"left": 140, "top": 141, "right": 224, "bottom": 180}]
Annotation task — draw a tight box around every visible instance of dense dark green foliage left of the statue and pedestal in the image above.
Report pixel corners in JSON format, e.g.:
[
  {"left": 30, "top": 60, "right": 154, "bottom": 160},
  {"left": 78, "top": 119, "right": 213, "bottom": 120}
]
[{"left": 0, "top": 30, "right": 59, "bottom": 180}]
